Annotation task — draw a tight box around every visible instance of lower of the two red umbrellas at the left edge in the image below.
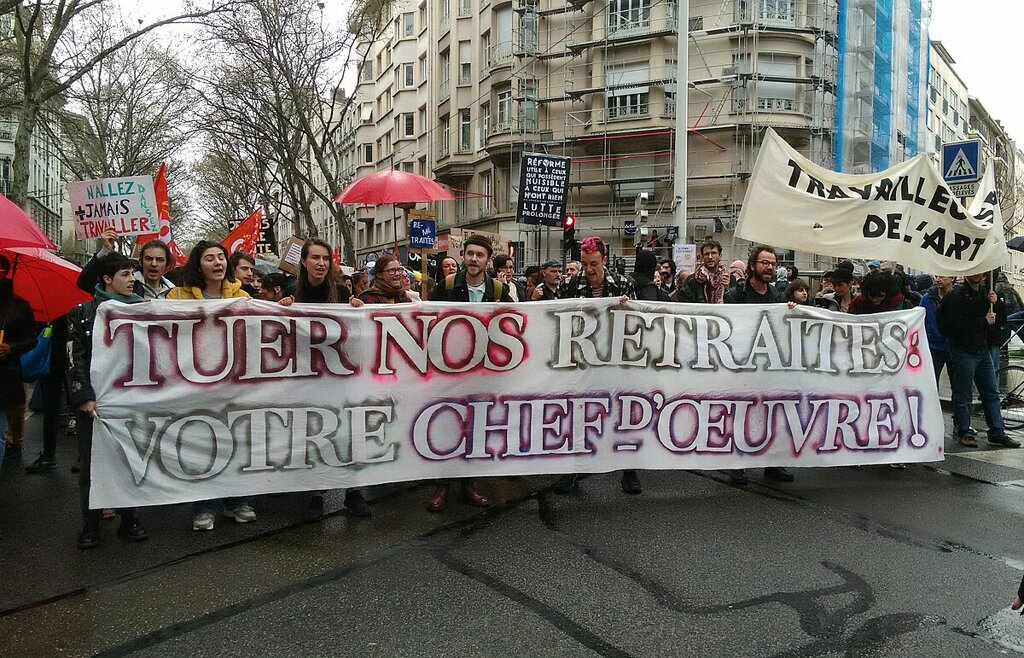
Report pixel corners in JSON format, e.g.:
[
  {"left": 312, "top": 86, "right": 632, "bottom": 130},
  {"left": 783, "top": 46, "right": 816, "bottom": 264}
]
[{"left": 0, "top": 247, "right": 92, "bottom": 322}]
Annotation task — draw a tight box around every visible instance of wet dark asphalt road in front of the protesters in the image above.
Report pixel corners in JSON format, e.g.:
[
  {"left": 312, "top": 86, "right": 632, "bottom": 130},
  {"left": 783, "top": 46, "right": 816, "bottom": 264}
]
[{"left": 0, "top": 409, "right": 1024, "bottom": 657}]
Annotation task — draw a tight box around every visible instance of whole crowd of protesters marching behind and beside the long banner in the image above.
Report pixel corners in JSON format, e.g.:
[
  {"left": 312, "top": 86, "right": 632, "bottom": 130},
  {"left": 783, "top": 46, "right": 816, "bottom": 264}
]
[{"left": 0, "top": 228, "right": 1024, "bottom": 549}]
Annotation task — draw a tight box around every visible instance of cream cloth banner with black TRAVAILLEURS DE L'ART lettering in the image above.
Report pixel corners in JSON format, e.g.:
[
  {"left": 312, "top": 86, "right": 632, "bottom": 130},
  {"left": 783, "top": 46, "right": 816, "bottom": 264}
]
[{"left": 736, "top": 129, "right": 1008, "bottom": 275}]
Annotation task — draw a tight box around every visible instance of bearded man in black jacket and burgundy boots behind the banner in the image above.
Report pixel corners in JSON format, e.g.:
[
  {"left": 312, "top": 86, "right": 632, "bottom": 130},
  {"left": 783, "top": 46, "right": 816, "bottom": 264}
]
[{"left": 427, "top": 234, "right": 512, "bottom": 512}]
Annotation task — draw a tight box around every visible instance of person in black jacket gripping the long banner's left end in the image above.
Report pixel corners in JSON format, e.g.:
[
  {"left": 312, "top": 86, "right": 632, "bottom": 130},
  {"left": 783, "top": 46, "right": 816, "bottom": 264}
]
[{"left": 69, "top": 253, "right": 150, "bottom": 549}]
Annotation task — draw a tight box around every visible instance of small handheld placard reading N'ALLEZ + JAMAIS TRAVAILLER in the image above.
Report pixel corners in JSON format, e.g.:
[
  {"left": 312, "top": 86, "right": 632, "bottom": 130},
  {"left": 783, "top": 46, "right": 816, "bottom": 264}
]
[{"left": 68, "top": 176, "right": 160, "bottom": 239}]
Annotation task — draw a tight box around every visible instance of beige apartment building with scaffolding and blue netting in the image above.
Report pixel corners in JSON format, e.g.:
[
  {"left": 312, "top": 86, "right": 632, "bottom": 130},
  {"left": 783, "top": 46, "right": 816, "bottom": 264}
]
[{"left": 354, "top": 0, "right": 928, "bottom": 269}]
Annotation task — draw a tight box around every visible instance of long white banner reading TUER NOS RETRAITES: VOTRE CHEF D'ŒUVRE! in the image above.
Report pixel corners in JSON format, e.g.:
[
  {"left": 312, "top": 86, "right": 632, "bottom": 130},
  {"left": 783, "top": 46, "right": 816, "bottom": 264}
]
[{"left": 90, "top": 300, "right": 943, "bottom": 508}]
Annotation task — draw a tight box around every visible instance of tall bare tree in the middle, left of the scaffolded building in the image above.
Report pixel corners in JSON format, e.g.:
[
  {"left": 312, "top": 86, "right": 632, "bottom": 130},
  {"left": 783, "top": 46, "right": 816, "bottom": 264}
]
[{"left": 195, "top": 0, "right": 393, "bottom": 262}]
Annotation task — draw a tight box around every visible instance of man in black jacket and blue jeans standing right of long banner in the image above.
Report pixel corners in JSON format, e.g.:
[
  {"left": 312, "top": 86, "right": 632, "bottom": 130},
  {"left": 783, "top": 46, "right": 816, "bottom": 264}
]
[{"left": 937, "top": 273, "right": 1021, "bottom": 448}]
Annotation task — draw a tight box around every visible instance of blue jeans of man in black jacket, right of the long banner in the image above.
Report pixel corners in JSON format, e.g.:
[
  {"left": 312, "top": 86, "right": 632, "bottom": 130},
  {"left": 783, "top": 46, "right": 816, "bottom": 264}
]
[{"left": 949, "top": 348, "right": 1007, "bottom": 440}]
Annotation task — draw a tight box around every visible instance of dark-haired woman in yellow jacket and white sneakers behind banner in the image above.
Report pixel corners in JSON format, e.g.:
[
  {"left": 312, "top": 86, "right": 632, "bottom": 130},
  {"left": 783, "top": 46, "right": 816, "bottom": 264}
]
[{"left": 167, "top": 239, "right": 256, "bottom": 530}]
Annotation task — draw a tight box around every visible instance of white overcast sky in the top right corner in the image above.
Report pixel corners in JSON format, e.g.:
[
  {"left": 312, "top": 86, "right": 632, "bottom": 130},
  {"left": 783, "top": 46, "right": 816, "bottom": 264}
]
[{"left": 930, "top": 0, "right": 1024, "bottom": 141}]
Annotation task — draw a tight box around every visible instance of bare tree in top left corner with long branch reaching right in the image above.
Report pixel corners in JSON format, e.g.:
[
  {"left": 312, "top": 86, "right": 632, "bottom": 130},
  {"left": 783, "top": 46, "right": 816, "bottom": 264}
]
[{"left": 0, "top": 0, "right": 239, "bottom": 206}]
